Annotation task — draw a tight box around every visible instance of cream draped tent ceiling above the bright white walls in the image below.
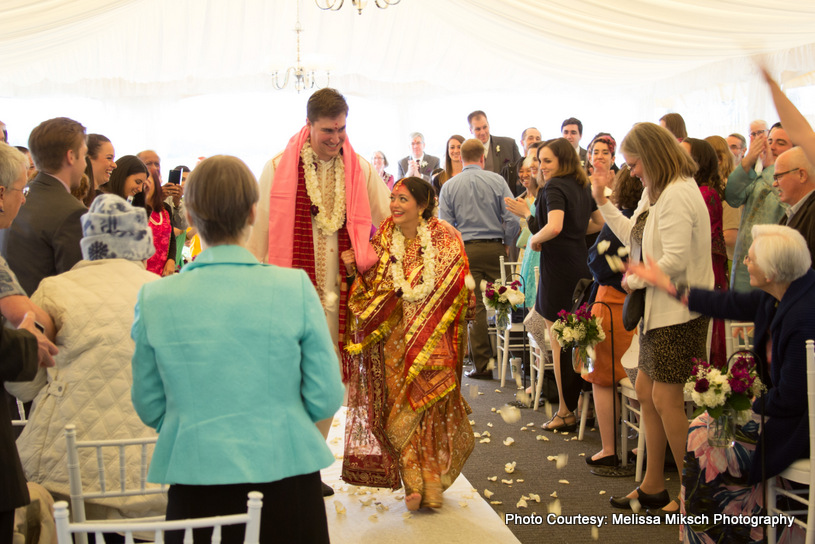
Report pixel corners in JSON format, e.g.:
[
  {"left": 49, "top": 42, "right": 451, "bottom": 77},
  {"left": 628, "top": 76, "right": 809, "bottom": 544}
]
[{"left": 0, "top": 0, "right": 815, "bottom": 97}]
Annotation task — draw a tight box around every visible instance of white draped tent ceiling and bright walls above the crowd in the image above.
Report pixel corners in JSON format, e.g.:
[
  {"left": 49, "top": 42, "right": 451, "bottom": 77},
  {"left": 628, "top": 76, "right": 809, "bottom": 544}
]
[{"left": 0, "top": 0, "right": 815, "bottom": 174}]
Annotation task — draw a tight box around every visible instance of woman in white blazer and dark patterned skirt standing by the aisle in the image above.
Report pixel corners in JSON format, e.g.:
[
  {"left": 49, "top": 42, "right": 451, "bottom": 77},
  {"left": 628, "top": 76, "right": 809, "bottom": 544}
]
[{"left": 592, "top": 123, "right": 713, "bottom": 514}]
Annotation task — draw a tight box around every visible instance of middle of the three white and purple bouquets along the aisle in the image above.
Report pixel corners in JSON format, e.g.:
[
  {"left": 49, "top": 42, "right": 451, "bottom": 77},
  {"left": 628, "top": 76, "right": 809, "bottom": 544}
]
[{"left": 552, "top": 304, "right": 606, "bottom": 373}]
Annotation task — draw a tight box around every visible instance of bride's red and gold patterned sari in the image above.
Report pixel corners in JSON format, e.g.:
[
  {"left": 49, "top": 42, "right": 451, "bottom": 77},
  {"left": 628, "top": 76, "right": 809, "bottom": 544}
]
[{"left": 342, "top": 218, "right": 475, "bottom": 507}]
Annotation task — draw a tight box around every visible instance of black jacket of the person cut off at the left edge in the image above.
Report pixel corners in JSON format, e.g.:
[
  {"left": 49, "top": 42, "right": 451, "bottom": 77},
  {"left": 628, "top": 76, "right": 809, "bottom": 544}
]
[{"left": 0, "top": 325, "right": 37, "bottom": 512}]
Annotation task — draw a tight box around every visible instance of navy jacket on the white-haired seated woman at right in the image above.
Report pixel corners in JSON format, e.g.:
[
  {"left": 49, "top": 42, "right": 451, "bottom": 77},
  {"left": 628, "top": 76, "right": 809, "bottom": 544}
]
[{"left": 688, "top": 269, "right": 815, "bottom": 483}]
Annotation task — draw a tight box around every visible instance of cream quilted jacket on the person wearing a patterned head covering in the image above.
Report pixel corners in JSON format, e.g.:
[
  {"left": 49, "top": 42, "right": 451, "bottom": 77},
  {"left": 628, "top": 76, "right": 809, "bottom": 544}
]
[{"left": 6, "top": 259, "right": 166, "bottom": 519}]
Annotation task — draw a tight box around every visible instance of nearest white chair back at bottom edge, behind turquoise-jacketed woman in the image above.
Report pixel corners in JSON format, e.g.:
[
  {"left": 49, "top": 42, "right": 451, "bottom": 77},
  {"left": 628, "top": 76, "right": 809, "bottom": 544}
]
[{"left": 54, "top": 491, "right": 263, "bottom": 544}]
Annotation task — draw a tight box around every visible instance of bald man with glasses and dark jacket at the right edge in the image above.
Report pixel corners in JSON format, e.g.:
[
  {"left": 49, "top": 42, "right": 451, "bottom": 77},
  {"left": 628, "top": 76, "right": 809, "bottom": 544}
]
[{"left": 773, "top": 147, "right": 815, "bottom": 263}]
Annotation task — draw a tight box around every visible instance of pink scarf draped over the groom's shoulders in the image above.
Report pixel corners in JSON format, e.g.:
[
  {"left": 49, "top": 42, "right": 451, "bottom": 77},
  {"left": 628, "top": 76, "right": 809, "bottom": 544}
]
[{"left": 269, "top": 125, "right": 378, "bottom": 272}]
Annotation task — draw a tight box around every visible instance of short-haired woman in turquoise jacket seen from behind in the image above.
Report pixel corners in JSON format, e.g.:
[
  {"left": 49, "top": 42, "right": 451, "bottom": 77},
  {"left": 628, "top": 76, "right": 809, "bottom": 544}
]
[{"left": 131, "top": 155, "right": 345, "bottom": 543}]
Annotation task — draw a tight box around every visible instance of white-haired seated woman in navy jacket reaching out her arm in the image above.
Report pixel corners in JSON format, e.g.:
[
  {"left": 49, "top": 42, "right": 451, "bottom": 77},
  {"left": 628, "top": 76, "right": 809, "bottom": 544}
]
[{"left": 631, "top": 225, "right": 815, "bottom": 542}]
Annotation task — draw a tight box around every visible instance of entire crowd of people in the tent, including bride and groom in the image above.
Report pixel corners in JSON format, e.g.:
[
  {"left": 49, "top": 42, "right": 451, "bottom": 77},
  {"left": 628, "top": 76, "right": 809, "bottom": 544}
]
[{"left": 0, "top": 65, "right": 815, "bottom": 542}]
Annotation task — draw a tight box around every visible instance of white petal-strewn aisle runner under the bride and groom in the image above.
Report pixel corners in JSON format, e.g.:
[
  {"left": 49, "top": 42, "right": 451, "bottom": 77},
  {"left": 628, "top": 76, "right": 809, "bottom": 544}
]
[{"left": 321, "top": 408, "right": 519, "bottom": 544}]
